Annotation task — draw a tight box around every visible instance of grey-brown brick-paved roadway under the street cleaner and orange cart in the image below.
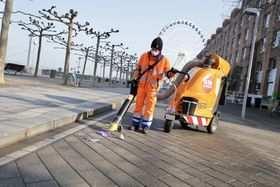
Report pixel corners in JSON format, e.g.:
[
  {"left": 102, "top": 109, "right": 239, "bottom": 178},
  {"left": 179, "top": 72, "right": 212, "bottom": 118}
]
[{"left": 0, "top": 75, "right": 280, "bottom": 187}]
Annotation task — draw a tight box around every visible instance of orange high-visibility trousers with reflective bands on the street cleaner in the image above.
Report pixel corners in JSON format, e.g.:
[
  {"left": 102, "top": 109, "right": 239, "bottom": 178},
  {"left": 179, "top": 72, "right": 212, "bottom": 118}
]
[{"left": 132, "top": 87, "right": 157, "bottom": 129}]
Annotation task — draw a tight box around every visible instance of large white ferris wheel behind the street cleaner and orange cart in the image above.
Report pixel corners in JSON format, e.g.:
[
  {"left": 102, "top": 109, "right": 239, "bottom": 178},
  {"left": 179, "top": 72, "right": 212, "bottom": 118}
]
[{"left": 159, "top": 20, "right": 206, "bottom": 69}]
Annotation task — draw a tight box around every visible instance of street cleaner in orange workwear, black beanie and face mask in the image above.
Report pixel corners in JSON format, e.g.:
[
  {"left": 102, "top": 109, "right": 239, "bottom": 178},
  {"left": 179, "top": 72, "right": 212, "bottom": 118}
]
[{"left": 129, "top": 37, "right": 176, "bottom": 134}]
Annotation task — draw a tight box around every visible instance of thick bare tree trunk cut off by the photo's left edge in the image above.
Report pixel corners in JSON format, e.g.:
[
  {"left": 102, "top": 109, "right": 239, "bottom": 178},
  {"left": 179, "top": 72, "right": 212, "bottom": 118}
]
[{"left": 0, "top": 0, "right": 13, "bottom": 86}]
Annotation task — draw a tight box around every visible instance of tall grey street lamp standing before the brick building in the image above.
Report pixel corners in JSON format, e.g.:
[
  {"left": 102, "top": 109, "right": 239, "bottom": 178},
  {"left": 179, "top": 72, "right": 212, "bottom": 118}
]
[{"left": 241, "top": 8, "right": 259, "bottom": 120}]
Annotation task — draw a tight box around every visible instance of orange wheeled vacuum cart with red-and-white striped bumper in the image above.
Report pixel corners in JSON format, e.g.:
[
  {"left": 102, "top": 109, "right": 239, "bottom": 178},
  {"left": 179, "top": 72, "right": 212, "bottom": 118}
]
[{"left": 164, "top": 54, "right": 230, "bottom": 133}]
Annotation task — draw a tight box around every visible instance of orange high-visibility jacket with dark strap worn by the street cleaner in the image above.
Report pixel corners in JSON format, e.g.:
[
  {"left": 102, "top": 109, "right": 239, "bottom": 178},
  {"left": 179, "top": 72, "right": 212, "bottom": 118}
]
[{"left": 134, "top": 51, "right": 174, "bottom": 93}]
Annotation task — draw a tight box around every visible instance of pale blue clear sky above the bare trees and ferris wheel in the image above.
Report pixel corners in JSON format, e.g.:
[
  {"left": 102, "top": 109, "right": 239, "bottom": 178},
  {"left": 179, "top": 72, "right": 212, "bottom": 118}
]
[{"left": 0, "top": 0, "right": 236, "bottom": 75}]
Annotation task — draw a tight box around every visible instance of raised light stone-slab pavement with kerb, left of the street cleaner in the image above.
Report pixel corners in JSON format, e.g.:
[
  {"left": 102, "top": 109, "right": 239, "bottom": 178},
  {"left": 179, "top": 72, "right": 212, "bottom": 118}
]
[{"left": 0, "top": 76, "right": 125, "bottom": 148}]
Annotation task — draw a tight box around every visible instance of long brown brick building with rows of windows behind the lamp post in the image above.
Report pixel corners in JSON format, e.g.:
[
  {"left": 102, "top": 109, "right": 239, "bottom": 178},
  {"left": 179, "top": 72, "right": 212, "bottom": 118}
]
[{"left": 205, "top": 0, "right": 280, "bottom": 96}]
